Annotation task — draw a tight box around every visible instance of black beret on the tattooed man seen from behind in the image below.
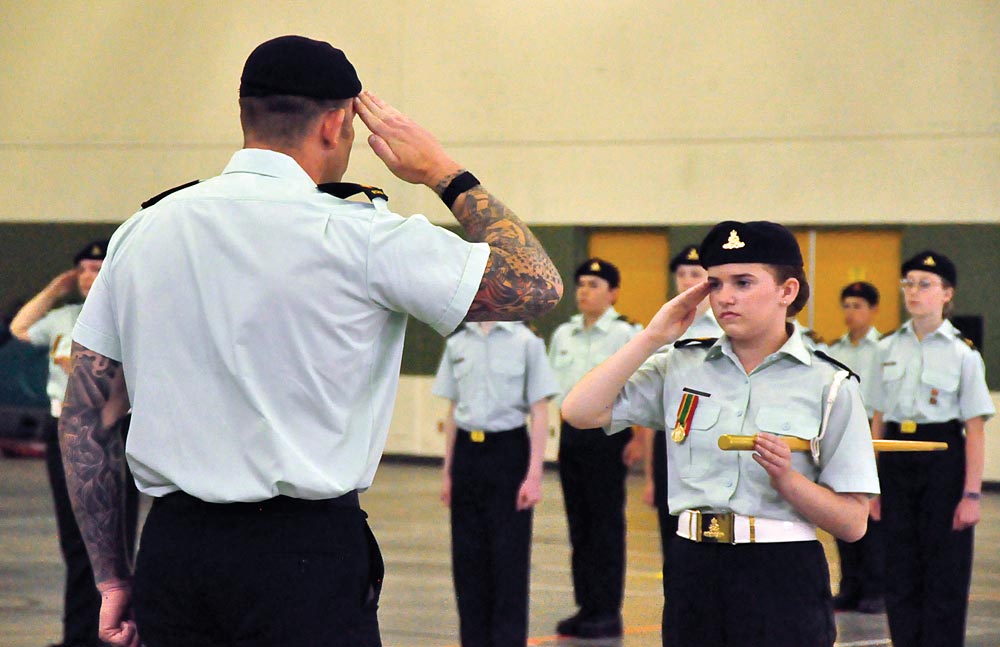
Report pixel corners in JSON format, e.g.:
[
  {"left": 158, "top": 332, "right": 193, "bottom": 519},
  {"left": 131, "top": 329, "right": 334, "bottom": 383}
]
[{"left": 240, "top": 36, "right": 361, "bottom": 100}]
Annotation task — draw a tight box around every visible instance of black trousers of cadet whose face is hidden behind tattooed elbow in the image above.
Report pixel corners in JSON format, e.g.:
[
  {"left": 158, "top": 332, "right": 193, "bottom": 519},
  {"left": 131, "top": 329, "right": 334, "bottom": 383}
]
[{"left": 451, "top": 427, "right": 532, "bottom": 647}]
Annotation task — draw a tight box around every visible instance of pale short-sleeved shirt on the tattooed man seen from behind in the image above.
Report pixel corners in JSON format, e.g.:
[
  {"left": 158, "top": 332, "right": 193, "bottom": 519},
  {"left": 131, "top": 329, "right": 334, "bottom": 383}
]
[{"left": 74, "top": 149, "right": 489, "bottom": 502}]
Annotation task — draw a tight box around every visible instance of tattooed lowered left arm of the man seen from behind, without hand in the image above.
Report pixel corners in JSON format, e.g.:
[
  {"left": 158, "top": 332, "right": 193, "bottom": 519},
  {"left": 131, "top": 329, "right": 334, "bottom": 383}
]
[{"left": 59, "top": 342, "right": 131, "bottom": 584}]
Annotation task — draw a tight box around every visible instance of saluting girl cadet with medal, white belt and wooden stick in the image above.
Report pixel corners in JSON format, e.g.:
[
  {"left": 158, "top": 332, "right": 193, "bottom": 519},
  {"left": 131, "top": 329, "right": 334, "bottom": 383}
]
[{"left": 562, "top": 221, "right": 878, "bottom": 647}]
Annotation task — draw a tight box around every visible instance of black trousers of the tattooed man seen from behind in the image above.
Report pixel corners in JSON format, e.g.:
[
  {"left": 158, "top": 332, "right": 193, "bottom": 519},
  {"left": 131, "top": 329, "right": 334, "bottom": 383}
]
[{"left": 133, "top": 492, "right": 384, "bottom": 647}]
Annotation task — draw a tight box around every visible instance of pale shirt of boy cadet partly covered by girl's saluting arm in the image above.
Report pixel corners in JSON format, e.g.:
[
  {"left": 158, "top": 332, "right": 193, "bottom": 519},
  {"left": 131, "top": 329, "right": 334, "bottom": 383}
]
[{"left": 549, "top": 308, "right": 642, "bottom": 404}]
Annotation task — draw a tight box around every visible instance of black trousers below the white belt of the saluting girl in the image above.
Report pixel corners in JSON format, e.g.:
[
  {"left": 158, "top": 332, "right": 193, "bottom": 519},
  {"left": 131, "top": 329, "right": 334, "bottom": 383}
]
[{"left": 663, "top": 538, "right": 837, "bottom": 647}]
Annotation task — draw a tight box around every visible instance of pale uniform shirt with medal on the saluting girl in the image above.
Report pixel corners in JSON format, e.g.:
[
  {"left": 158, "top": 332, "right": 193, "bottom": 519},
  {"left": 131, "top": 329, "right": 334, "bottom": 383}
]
[{"left": 608, "top": 331, "right": 879, "bottom": 523}]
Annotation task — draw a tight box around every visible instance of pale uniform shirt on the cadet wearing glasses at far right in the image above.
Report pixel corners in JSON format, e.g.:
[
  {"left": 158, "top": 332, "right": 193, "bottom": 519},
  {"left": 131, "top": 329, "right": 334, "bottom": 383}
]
[{"left": 872, "top": 319, "right": 996, "bottom": 424}]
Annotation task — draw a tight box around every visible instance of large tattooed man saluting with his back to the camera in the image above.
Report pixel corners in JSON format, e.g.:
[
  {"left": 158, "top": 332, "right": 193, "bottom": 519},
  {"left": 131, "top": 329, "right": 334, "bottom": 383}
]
[{"left": 60, "top": 36, "right": 562, "bottom": 647}]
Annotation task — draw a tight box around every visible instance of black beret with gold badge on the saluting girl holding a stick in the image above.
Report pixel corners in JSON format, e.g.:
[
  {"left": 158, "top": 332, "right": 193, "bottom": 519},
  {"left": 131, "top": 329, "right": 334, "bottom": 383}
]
[{"left": 698, "top": 220, "right": 802, "bottom": 268}]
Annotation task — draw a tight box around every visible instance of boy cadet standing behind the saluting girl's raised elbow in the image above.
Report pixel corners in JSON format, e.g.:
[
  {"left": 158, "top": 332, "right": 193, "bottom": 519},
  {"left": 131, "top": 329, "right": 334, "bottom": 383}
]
[{"left": 549, "top": 258, "right": 644, "bottom": 638}]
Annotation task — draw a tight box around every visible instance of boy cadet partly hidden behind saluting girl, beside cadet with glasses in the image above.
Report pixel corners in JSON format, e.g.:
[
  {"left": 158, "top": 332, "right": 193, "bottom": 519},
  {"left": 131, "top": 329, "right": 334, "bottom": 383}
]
[{"left": 830, "top": 281, "right": 885, "bottom": 613}]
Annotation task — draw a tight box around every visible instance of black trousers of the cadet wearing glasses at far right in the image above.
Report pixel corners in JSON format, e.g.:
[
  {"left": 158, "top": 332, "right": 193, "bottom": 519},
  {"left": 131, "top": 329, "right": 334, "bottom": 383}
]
[{"left": 878, "top": 421, "right": 974, "bottom": 647}]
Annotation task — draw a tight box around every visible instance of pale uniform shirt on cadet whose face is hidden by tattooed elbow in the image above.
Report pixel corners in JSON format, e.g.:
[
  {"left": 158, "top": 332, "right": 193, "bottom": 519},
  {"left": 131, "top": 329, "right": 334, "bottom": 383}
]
[{"left": 431, "top": 321, "right": 559, "bottom": 432}]
